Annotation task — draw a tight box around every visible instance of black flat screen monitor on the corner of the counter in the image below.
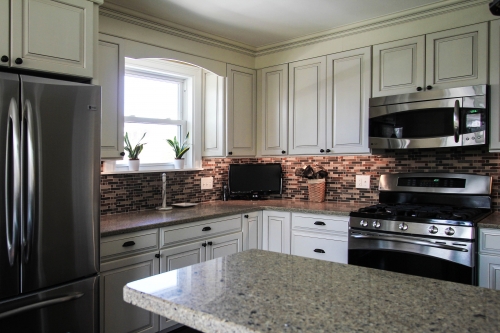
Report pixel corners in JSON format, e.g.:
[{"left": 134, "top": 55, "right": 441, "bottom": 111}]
[{"left": 229, "top": 163, "right": 282, "bottom": 199}]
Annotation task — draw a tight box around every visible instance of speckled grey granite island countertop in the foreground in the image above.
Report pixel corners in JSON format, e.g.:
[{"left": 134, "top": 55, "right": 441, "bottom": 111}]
[{"left": 124, "top": 250, "right": 500, "bottom": 333}]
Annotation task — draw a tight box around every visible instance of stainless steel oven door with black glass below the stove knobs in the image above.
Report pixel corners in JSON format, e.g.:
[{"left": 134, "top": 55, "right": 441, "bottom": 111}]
[{"left": 348, "top": 229, "right": 476, "bottom": 285}]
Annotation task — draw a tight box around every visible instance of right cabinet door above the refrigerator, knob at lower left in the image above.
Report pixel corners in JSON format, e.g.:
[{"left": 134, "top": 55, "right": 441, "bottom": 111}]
[{"left": 10, "top": 0, "right": 94, "bottom": 77}]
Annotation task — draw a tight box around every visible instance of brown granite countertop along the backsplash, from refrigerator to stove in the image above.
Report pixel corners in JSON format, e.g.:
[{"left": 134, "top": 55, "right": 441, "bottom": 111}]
[{"left": 101, "top": 200, "right": 366, "bottom": 237}]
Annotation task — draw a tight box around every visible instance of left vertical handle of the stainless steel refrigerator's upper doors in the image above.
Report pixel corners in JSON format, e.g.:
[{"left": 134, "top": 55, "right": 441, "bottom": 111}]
[{"left": 4, "top": 99, "right": 21, "bottom": 266}]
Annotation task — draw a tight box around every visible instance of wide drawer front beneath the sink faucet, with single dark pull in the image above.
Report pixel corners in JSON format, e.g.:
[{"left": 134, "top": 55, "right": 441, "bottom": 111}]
[{"left": 160, "top": 215, "right": 242, "bottom": 247}]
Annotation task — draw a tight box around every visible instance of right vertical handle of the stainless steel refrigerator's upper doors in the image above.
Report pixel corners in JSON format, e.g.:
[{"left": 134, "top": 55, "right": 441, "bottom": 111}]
[{"left": 21, "top": 100, "right": 36, "bottom": 262}]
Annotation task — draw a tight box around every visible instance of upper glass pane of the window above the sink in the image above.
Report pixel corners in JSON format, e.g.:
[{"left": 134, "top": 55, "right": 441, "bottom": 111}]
[{"left": 125, "top": 75, "right": 181, "bottom": 120}]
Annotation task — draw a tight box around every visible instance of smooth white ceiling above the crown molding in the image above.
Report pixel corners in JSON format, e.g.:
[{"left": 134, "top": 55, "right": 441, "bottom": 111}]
[{"left": 105, "top": 0, "right": 444, "bottom": 47}]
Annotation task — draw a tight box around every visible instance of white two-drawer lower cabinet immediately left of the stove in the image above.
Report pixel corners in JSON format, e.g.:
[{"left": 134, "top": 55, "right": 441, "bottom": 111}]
[{"left": 291, "top": 213, "right": 349, "bottom": 264}]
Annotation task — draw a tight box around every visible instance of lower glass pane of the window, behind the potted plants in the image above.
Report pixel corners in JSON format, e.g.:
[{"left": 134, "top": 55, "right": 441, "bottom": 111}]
[{"left": 124, "top": 123, "right": 180, "bottom": 164}]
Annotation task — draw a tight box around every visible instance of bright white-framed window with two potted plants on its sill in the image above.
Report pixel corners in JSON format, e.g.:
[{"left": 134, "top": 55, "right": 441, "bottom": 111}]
[{"left": 117, "top": 58, "right": 201, "bottom": 171}]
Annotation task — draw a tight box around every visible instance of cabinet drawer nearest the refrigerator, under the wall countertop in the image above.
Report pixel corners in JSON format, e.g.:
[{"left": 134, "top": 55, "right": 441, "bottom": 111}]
[{"left": 101, "top": 229, "right": 158, "bottom": 260}]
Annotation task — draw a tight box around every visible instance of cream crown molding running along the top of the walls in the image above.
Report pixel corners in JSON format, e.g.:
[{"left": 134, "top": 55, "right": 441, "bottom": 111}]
[{"left": 99, "top": 0, "right": 490, "bottom": 57}]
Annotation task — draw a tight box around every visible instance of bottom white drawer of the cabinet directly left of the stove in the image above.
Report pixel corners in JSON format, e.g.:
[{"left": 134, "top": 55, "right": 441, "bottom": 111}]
[{"left": 292, "top": 231, "right": 347, "bottom": 264}]
